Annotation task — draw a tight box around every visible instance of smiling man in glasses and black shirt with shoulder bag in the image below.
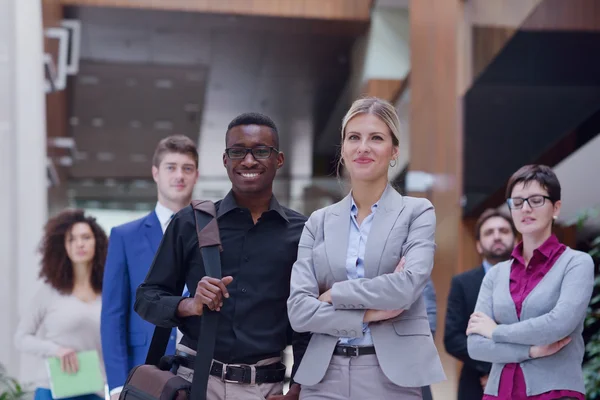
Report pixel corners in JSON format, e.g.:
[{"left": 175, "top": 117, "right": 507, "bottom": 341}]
[{"left": 134, "top": 113, "right": 309, "bottom": 400}]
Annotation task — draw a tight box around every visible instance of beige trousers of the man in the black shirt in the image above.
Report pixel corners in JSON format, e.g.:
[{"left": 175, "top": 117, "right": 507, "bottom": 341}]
[{"left": 177, "top": 344, "right": 283, "bottom": 400}]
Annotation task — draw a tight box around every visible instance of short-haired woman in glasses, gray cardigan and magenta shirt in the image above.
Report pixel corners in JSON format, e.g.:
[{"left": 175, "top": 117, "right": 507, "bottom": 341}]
[{"left": 467, "top": 165, "right": 594, "bottom": 400}]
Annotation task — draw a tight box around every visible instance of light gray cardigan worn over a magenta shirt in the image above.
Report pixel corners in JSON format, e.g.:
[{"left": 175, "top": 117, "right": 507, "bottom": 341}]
[{"left": 467, "top": 247, "right": 594, "bottom": 396}]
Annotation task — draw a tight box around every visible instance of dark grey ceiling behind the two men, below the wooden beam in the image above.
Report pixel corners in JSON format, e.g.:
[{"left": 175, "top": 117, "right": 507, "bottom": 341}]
[{"left": 68, "top": 7, "right": 366, "bottom": 208}]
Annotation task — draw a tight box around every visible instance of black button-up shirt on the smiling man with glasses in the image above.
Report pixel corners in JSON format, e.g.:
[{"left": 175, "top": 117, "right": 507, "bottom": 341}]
[{"left": 134, "top": 192, "right": 309, "bottom": 372}]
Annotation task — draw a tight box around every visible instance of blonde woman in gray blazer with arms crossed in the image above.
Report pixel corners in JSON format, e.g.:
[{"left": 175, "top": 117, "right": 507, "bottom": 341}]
[{"left": 288, "top": 98, "right": 445, "bottom": 400}]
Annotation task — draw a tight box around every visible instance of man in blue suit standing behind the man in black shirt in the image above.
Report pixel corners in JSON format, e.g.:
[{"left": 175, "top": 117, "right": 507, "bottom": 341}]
[{"left": 101, "top": 135, "right": 198, "bottom": 399}]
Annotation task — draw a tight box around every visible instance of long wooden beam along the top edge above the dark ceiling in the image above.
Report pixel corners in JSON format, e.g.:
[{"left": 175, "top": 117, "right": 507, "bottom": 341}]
[{"left": 60, "top": 0, "right": 373, "bottom": 21}]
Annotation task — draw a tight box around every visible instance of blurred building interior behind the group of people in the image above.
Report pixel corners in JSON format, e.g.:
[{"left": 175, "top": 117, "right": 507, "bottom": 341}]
[{"left": 0, "top": 0, "right": 600, "bottom": 399}]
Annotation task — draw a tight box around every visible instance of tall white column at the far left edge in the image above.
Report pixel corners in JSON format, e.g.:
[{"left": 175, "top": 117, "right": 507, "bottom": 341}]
[{"left": 0, "top": 0, "right": 47, "bottom": 378}]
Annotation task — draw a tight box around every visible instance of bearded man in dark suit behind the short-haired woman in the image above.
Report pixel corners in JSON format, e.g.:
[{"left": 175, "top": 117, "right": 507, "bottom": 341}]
[{"left": 444, "top": 209, "right": 516, "bottom": 400}]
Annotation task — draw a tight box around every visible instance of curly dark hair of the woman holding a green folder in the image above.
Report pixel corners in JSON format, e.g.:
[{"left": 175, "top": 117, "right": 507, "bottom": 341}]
[{"left": 39, "top": 209, "right": 108, "bottom": 294}]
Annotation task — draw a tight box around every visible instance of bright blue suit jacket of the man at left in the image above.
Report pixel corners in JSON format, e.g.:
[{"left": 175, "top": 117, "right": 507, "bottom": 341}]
[{"left": 100, "top": 211, "right": 177, "bottom": 390}]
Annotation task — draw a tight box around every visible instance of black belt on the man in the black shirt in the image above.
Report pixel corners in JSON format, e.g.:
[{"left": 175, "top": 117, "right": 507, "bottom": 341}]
[{"left": 176, "top": 350, "right": 286, "bottom": 384}]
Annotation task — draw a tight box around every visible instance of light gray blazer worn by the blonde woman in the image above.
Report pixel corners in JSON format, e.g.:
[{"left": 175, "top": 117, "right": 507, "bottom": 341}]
[{"left": 288, "top": 186, "right": 446, "bottom": 387}]
